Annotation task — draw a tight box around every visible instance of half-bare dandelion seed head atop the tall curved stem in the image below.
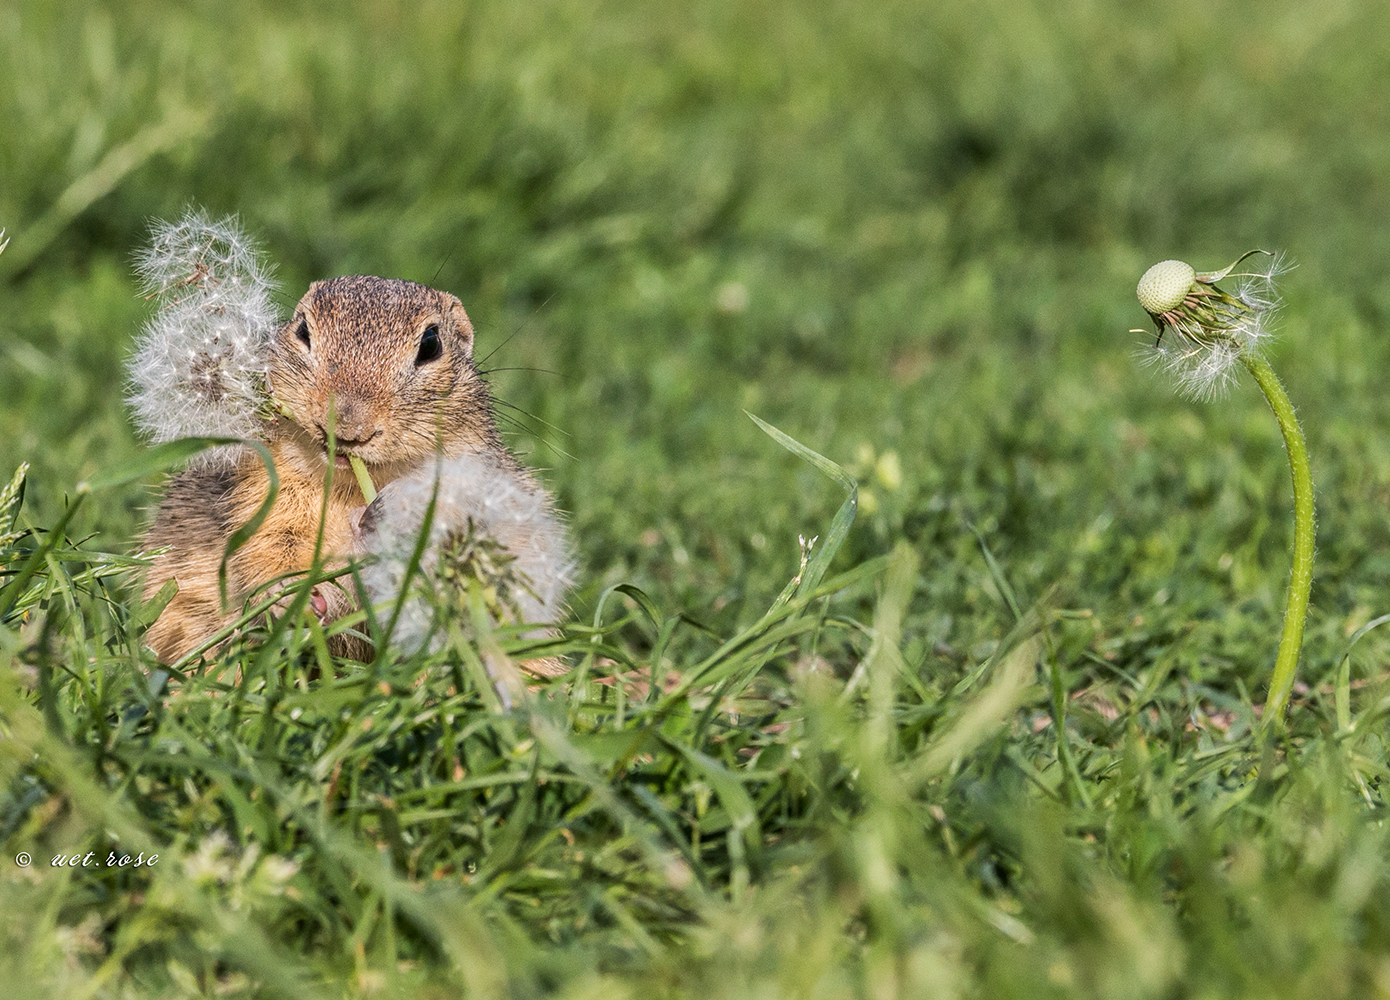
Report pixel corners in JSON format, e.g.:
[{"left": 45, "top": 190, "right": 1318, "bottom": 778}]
[{"left": 1134, "top": 250, "right": 1287, "bottom": 399}]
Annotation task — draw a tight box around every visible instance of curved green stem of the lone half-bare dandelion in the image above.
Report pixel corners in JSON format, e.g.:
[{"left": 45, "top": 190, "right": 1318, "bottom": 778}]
[{"left": 1241, "top": 353, "right": 1314, "bottom": 730}]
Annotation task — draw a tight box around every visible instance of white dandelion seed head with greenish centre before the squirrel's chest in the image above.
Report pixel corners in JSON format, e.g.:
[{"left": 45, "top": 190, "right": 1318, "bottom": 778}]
[{"left": 359, "top": 453, "right": 575, "bottom": 652}]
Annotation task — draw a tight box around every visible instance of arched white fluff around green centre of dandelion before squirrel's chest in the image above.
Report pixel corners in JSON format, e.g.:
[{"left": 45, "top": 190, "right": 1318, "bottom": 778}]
[{"left": 360, "top": 453, "right": 575, "bottom": 652}]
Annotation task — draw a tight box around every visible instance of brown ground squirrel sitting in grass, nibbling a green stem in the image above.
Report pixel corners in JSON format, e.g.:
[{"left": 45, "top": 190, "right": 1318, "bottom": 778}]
[{"left": 145, "top": 277, "right": 569, "bottom": 670}]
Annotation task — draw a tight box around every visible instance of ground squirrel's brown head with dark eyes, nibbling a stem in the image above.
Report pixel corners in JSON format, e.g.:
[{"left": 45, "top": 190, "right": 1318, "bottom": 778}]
[{"left": 270, "top": 277, "right": 495, "bottom": 481}]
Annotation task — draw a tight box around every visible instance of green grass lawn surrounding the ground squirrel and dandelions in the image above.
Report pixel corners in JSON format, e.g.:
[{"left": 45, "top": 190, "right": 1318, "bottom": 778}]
[{"left": 0, "top": 0, "right": 1390, "bottom": 1000}]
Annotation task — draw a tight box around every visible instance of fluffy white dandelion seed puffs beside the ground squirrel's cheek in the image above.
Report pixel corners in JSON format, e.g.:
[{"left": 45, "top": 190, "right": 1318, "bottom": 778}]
[{"left": 128, "top": 210, "right": 279, "bottom": 444}]
